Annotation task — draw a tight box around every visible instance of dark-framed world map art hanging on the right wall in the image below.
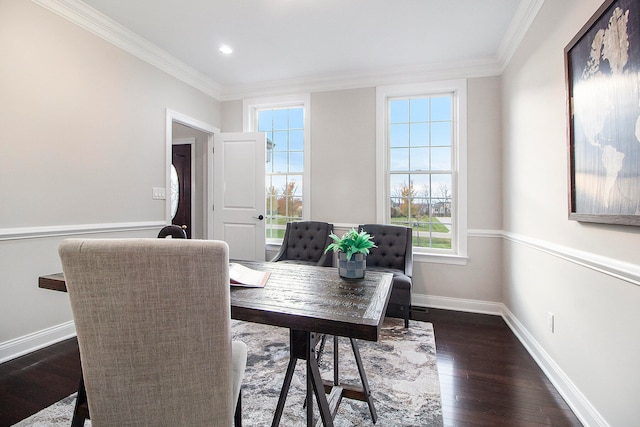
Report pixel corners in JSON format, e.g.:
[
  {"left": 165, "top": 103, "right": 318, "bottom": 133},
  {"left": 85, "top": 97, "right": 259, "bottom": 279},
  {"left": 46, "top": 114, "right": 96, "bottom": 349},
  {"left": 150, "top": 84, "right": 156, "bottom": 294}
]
[{"left": 564, "top": 0, "right": 640, "bottom": 225}]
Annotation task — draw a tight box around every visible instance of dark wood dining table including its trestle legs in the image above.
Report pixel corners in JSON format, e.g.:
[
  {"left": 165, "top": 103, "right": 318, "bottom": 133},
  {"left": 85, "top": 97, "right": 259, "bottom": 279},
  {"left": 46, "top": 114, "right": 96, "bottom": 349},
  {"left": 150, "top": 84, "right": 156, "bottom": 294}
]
[{"left": 38, "top": 260, "right": 392, "bottom": 426}]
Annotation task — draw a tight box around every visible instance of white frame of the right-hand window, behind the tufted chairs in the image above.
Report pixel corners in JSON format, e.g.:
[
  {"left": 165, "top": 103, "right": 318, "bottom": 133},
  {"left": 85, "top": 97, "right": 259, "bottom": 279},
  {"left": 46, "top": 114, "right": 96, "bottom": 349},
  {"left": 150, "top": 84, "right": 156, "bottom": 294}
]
[{"left": 376, "top": 79, "right": 468, "bottom": 265}]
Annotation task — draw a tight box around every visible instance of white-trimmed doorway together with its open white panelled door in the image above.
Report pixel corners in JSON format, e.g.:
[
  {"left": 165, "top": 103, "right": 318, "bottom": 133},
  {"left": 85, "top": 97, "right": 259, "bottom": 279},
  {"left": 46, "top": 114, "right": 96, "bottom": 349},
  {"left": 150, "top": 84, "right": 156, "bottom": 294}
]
[{"left": 165, "top": 110, "right": 266, "bottom": 260}]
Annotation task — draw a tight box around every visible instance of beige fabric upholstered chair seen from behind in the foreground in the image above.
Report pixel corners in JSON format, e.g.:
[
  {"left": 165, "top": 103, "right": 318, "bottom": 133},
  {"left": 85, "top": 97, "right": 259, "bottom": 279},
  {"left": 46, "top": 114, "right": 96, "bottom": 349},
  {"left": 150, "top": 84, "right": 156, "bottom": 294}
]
[{"left": 59, "top": 239, "right": 247, "bottom": 427}]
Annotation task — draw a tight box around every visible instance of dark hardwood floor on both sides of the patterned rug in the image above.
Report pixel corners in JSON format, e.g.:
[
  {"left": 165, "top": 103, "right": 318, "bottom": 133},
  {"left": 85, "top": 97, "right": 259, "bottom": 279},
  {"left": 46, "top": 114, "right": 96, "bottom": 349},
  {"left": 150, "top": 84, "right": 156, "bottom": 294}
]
[{"left": 0, "top": 309, "right": 581, "bottom": 427}]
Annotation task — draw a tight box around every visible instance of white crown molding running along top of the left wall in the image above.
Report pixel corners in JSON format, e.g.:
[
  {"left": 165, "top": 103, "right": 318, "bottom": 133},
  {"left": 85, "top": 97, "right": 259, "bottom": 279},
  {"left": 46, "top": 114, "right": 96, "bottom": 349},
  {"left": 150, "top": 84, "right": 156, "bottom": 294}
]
[{"left": 31, "top": 0, "right": 221, "bottom": 99}]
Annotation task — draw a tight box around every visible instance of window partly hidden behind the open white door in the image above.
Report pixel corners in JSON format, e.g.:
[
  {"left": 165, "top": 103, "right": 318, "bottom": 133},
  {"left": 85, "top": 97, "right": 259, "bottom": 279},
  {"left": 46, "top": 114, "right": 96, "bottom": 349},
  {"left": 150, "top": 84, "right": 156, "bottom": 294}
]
[{"left": 245, "top": 97, "right": 309, "bottom": 243}]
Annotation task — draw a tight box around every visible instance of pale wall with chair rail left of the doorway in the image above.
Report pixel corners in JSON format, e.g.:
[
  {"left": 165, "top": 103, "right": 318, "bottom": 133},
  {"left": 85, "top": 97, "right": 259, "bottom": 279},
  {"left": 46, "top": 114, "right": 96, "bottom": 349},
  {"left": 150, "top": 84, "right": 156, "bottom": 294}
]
[{"left": 0, "top": 0, "right": 220, "bottom": 354}]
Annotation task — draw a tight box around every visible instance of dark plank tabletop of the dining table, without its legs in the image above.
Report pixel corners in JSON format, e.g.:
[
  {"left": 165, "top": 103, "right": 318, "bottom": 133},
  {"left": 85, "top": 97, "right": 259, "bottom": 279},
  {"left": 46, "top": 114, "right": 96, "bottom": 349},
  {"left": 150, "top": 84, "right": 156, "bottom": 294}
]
[{"left": 38, "top": 260, "right": 392, "bottom": 341}]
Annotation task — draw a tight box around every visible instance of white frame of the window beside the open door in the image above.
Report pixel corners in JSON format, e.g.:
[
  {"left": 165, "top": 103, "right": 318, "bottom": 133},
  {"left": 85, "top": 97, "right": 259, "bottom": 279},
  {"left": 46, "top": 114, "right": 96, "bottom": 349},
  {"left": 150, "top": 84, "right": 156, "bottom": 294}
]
[{"left": 242, "top": 94, "right": 311, "bottom": 245}]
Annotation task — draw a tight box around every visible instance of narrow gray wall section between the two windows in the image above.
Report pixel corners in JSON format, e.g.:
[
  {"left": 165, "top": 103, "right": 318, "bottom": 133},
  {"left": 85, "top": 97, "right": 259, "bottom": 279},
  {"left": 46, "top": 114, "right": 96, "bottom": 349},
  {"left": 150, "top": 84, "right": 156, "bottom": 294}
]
[{"left": 310, "top": 88, "right": 376, "bottom": 224}]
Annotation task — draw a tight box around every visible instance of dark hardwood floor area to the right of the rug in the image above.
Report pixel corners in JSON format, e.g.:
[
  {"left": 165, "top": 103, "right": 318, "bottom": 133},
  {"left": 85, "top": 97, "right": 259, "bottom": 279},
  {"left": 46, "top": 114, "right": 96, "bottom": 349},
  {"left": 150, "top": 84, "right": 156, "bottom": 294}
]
[{"left": 414, "top": 309, "right": 582, "bottom": 426}]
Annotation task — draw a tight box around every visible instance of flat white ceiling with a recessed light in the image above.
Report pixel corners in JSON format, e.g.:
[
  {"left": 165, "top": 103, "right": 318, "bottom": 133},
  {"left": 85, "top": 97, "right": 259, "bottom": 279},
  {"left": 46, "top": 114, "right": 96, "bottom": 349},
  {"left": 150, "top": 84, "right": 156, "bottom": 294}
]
[{"left": 77, "top": 0, "right": 544, "bottom": 98}]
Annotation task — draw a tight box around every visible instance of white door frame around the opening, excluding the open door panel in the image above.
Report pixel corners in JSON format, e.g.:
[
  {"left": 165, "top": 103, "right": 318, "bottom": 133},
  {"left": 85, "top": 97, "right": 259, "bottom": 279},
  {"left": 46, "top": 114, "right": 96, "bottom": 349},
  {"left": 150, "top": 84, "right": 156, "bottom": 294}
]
[{"left": 164, "top": 108, "right": 220, "bottom": 239}]
